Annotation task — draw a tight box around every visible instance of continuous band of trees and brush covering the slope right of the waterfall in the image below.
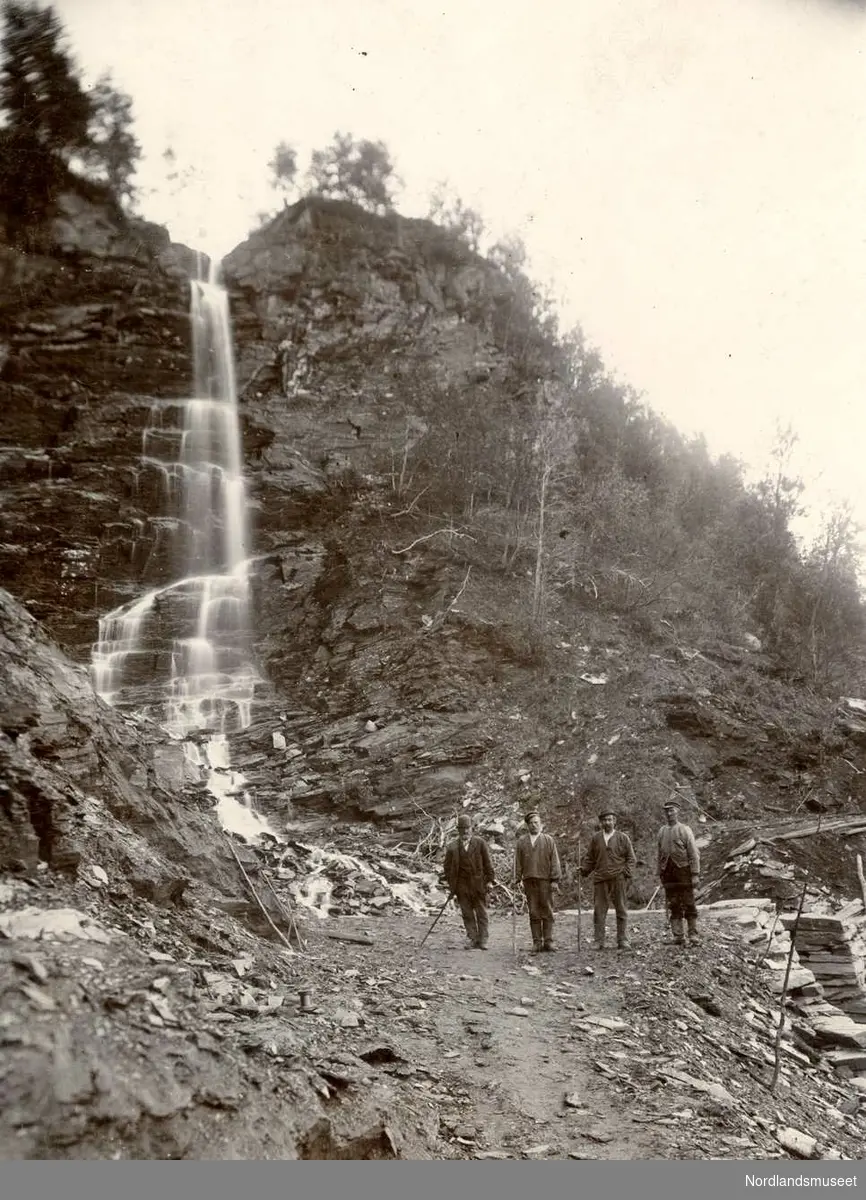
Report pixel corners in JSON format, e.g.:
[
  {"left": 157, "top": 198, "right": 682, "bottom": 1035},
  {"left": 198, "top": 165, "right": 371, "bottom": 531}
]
[{"left": 244, "top": 188, "right": 864, "bottom": 692}]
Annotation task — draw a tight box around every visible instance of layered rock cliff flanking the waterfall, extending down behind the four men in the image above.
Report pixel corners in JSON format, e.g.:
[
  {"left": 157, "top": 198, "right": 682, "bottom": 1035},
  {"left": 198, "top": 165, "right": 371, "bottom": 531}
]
[{"left": 0, "top": 194, "right": 866, "bottom": 864}]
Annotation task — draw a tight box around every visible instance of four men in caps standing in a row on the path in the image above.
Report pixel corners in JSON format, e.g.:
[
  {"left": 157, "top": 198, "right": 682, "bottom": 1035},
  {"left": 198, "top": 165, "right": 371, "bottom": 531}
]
[{"left": 443, "top": 799, "right": 700, "bottom": 953}]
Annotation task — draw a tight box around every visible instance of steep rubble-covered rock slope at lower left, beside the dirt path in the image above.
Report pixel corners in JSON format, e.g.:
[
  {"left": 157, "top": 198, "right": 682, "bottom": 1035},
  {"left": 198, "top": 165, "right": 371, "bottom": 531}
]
[{"left": 0, "top": 592, "right": 438, "bottom": 1158}]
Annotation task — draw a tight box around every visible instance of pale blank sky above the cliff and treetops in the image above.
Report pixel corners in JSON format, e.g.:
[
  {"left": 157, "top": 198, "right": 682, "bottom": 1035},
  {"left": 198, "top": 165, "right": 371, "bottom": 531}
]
[{"left": 53, "top": 0, "right": 866, "bottom": 540}]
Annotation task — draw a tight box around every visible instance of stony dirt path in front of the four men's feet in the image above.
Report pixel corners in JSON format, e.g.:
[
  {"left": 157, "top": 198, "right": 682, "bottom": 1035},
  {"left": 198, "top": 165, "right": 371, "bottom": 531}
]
[{"left": 309, "top": 907, "right": 691, "bottom": 1159}]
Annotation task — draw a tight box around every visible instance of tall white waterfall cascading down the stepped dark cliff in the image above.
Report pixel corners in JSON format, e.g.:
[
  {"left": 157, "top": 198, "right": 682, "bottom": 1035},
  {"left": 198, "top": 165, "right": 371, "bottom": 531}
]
[{"left": 92, "top": 262, "right": 269, "bottom": 836}]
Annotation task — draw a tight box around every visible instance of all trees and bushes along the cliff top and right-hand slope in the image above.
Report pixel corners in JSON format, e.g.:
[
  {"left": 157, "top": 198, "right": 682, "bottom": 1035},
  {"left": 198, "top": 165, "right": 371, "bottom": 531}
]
[{"left": 0, "top": 0, "right": 864, "bottom": 690}]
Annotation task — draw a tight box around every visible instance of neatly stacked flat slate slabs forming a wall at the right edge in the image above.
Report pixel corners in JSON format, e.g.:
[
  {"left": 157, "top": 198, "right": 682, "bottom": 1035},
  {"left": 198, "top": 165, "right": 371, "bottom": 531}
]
[{"left": 782, "top": 904, "right": 866, "bottom": 1024}]
